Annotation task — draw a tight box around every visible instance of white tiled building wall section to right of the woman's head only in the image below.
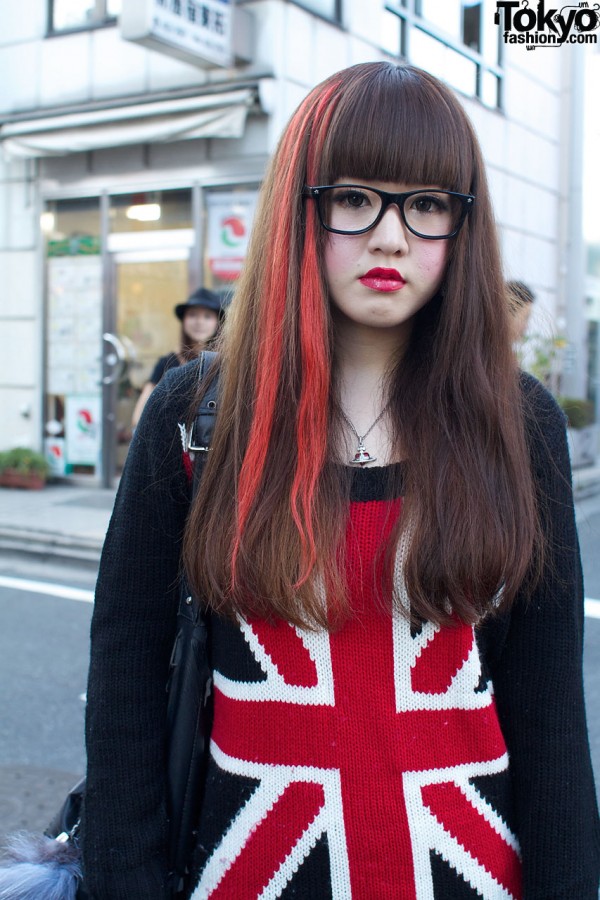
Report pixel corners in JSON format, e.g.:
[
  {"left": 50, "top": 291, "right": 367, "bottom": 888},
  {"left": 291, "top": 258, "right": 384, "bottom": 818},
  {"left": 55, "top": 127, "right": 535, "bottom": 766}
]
[{"left": 466, "top": 45, "right": 564, "bottom": 342}]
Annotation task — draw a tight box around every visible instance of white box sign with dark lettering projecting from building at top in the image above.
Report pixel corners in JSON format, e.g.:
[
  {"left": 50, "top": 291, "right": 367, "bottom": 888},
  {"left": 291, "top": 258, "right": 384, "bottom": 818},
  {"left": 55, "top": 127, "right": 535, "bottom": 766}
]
[{"left": 121, "top": 0, "right": 233, "bottom": 68}]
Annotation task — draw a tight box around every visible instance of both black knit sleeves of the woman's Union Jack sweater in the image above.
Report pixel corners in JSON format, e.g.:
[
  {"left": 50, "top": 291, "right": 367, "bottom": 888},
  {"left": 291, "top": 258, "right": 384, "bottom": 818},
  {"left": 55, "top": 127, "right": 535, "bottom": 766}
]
[{"left": 81, "top": 362, "right": 600, "bottom": 900}]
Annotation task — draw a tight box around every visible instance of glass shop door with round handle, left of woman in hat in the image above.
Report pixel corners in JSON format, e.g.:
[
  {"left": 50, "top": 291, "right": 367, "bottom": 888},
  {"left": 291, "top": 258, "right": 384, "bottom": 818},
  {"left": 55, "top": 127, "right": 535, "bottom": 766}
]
[{"left": 102, "top": 246, "right": 190, "bottom": 487}]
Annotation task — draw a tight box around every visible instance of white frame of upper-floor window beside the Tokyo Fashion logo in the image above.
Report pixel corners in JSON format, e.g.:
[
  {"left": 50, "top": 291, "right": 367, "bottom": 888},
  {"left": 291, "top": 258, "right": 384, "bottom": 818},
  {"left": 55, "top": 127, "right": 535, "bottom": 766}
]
[{"left": 385, "top": 0, "right": 504, "bottom": 111}]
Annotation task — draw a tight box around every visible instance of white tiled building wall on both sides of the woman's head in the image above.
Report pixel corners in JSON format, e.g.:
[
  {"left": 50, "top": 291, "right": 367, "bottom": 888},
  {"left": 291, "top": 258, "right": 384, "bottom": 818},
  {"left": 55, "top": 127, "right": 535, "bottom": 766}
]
[{"left": 0, "top": 0, "right": 579, "bottom": 449}]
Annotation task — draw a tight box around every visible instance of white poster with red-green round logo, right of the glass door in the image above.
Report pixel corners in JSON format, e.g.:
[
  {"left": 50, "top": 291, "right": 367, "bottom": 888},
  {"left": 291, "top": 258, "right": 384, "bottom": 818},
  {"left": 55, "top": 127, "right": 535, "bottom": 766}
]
[{"left": 206, "top": 191, "right": 256, "bottom": 281}]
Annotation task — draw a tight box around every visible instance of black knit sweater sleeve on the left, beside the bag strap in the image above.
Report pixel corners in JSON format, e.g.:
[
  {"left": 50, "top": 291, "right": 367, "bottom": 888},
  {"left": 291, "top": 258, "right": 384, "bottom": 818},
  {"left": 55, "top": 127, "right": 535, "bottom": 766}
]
[{"left": 81, "top": 364, "right": 196, "bottom": 900}]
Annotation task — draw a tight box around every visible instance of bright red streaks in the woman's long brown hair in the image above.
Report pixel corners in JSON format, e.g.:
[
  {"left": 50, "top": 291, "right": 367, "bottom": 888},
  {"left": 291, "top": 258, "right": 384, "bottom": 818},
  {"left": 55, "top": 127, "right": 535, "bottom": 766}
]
[{"left": 231, "top": 84, "right": 338, "bottom": 589}]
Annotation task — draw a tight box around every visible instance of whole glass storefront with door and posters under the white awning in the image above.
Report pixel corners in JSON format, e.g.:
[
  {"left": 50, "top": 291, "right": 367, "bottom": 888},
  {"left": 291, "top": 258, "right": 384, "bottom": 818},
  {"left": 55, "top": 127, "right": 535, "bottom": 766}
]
[{"left": 41, "top": 185, "right": 258, "bottom": 483}]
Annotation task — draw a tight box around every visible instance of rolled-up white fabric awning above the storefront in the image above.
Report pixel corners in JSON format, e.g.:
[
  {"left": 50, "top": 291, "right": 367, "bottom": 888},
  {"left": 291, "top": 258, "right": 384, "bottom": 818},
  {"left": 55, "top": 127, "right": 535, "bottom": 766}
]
[{"left": 0, "top": 88, "right": 255, "bottom": 158}]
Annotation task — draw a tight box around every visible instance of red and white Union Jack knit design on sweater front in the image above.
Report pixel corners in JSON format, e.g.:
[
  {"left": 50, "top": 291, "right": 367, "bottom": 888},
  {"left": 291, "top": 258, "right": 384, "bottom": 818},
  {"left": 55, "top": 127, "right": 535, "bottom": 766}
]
[{"left": 193, "top": 500, "right": 521, "bottom": 900}]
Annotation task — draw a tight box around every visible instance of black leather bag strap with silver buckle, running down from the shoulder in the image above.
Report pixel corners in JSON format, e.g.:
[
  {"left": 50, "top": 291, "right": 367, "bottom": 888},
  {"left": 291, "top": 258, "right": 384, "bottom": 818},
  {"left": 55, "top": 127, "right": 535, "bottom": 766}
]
[{"left": 167, "top": 350, "right": 218, "bottom": 896}]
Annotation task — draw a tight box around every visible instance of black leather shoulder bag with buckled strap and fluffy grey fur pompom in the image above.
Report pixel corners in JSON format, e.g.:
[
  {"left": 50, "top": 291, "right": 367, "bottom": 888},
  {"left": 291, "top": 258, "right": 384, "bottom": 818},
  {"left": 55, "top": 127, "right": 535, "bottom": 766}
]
[{"left": 0, "top": 351, "right": 218, "bottom": 900}]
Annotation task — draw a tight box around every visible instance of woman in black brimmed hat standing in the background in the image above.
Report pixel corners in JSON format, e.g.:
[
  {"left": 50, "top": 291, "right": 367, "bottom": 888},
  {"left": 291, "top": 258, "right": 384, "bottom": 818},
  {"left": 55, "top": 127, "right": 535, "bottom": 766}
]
[{"left": 131, "top": 288, "right": 223, "bottom": 428}]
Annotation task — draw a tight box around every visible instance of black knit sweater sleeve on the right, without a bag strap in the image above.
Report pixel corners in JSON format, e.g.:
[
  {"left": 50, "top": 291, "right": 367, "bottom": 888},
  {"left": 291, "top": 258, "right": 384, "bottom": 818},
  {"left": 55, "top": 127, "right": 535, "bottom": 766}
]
[{"left": 488, "top": 376, "right": 600, "bottom": 900}]
